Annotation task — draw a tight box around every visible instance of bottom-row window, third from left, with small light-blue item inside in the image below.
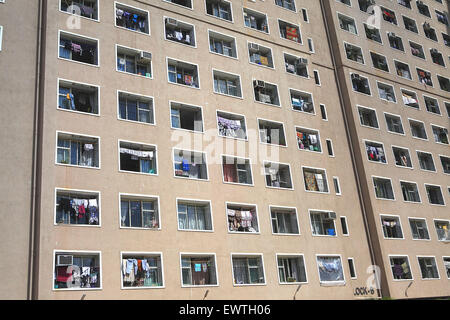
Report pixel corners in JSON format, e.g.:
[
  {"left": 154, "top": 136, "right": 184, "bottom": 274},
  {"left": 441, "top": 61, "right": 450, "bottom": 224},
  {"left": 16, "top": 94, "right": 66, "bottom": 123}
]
[{"left": 181, "top": 253, "right": 218, "bottom": 287}]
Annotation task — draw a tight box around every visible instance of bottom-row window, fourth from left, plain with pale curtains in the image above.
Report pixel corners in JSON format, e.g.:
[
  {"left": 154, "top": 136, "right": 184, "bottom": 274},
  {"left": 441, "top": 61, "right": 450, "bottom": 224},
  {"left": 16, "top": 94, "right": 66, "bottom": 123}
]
[{"left": 231, "top": 254, "right": 266, "bottom": 285}]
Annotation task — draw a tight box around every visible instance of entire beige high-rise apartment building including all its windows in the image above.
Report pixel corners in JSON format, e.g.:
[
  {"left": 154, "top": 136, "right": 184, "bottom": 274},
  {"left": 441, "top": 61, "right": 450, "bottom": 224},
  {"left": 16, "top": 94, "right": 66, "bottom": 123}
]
[{"left": 0, "top": 0, "right": 450, "bottom": 300}]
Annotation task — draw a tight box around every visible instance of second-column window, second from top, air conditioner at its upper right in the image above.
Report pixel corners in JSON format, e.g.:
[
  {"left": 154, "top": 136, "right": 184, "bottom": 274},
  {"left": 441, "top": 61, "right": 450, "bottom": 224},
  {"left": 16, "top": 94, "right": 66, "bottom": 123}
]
[{"left": 117, "top": 46, "right": 152, "bottom": 78}]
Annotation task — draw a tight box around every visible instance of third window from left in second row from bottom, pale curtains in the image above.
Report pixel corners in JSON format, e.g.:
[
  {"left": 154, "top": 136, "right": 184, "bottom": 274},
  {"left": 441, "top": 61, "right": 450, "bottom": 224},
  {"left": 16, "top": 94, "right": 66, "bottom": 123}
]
[{"left": 177, "top": 199, "right": 213, "bottom": 231}]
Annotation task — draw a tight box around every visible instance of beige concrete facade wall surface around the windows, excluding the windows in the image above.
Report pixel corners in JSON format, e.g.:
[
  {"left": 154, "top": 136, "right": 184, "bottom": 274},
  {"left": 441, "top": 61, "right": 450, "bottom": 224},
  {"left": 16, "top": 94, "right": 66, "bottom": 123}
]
[{"left": 0, "top": 0, "right": 450, "bottom": 300}]
